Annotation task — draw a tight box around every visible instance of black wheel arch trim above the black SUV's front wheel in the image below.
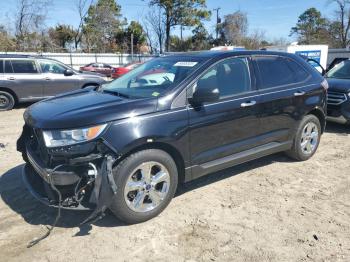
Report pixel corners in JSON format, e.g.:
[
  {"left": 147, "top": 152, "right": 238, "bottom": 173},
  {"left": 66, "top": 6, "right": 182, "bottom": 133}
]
[{"left": 116, "top": 142, "right": 185, "bottom": 183}]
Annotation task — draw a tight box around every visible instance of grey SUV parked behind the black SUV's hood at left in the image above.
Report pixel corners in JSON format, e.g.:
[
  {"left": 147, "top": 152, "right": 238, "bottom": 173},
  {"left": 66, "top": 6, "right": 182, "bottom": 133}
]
[{"left": 0, "top": 55, "right": 106, "bottom": 110}]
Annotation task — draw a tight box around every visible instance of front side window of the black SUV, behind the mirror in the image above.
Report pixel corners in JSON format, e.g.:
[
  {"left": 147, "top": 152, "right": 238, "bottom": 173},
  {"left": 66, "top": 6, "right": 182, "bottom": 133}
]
[{"left": 197, "top": 58, "right": 251, "bottom": 99}]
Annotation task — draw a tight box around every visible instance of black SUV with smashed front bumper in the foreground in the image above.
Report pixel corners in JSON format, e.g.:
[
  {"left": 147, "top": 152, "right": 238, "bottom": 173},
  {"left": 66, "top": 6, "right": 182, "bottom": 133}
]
[{"left": 17, "top": 51, "right": 327, "bottom": 223}]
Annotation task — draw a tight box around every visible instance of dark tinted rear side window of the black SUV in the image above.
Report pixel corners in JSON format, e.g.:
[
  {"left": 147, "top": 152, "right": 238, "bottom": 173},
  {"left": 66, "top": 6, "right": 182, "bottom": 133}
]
[{"left": 256, "top": 56, "right": 309, "bottom": 89}]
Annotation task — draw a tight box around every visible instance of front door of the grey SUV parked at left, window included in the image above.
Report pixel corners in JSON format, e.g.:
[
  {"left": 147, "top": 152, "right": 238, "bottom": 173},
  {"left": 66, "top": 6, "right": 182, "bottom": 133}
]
[{"left": 39, "top": 60, "right": 80, "bottom": 97}]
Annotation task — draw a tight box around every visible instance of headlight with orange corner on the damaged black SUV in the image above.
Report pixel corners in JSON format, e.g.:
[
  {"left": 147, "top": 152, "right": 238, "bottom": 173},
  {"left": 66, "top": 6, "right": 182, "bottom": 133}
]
[{"left": 43, "top": 124, "right": 107, "bottom": 147}]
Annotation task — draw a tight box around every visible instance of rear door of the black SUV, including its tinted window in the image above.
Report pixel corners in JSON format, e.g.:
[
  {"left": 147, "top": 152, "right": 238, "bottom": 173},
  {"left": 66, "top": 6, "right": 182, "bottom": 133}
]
[{"left": 253, "top": 56, "right": 311, "bottom": 143}]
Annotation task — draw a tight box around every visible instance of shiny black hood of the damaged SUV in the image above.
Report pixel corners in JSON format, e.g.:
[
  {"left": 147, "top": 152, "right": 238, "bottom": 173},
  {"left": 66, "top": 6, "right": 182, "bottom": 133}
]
[{"left": 24, "top": 89, "right": 157, "bottom": 129}]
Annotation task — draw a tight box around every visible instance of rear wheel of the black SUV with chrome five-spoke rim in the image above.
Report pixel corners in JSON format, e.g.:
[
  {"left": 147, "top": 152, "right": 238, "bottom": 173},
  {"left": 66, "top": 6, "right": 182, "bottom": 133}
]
[{"left": 286, "top": 115, "right": 322, "bottom": 161}]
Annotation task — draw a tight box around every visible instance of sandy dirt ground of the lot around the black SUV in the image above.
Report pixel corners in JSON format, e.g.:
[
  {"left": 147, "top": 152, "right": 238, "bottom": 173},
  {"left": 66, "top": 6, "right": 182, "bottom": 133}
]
[{"left": 0, "top": 108, "right": 350, "bottom": 262}]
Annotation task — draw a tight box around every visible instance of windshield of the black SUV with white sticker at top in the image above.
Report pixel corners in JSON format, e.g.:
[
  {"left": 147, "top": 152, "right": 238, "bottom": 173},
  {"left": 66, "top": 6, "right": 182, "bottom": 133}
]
[{"left": 102, "top": 56, "right": 202, "bottom": 98}]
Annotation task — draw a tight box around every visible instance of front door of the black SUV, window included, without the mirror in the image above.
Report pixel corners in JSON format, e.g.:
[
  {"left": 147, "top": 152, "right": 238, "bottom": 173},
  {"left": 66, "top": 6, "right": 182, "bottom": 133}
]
[{"left": 189, "top": 57, "right": 259, "bottom": 176}]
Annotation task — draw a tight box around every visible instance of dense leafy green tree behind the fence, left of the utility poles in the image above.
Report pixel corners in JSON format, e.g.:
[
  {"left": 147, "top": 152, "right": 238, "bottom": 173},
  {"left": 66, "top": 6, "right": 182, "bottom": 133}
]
[{"left": 83, "top": 0, "right": 124, "bottom": 52}]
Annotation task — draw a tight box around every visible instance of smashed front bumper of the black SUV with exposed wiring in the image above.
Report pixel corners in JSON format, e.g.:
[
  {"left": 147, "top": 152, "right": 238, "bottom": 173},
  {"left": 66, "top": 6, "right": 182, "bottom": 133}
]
[{"left": 17, "top": 126, "right": 117, "bottom": 213}]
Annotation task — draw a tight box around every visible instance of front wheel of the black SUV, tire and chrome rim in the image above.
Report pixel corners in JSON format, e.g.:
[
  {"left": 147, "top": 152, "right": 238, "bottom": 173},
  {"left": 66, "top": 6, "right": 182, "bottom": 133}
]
[{"left": 110, "top": 149, "right": 178, "bottom": 224}]
